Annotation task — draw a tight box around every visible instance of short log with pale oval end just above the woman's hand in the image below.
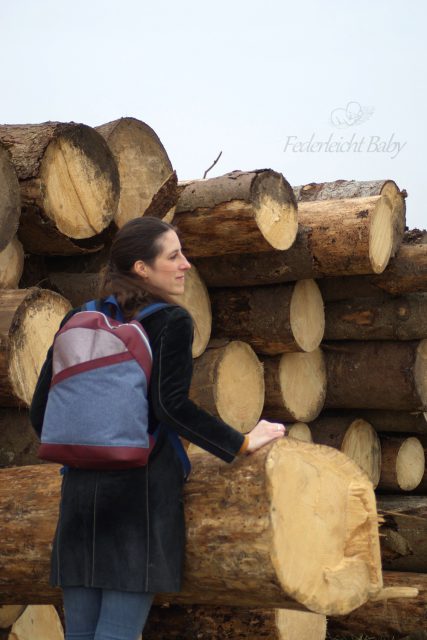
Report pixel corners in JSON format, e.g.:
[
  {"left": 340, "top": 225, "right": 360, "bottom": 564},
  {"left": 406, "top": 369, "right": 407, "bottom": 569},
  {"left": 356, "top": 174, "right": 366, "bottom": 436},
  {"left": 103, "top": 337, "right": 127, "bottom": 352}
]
[{"left": 190, "top": 340, "right": 264, "bottom": 433}]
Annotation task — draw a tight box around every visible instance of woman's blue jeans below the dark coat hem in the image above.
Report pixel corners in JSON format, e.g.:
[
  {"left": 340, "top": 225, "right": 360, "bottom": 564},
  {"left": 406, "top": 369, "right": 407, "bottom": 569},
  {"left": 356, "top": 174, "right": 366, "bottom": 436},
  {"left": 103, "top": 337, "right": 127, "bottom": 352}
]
[{"left": 63, "top": 587, "right": 154, "bottom": 640}]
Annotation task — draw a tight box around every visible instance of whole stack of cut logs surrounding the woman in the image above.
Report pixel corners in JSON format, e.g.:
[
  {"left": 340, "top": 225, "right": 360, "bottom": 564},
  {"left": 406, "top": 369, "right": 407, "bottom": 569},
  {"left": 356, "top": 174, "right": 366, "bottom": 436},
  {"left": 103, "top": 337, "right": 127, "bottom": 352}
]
[{"left": 0, "top": 118, "right": 427, "bottom": 640}]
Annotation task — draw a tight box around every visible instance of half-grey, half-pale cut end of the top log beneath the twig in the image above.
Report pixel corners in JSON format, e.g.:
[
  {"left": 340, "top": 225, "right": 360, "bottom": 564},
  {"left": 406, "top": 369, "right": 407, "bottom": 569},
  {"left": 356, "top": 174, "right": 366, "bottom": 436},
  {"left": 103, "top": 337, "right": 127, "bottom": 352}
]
[{"left": 252, "top": 171, "right": 298, "bottom": 250}]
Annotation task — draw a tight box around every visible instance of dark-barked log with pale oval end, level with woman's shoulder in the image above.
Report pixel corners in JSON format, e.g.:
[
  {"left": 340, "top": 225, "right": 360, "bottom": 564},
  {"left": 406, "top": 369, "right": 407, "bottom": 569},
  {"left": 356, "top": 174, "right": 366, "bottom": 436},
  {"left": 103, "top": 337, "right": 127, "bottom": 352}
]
[{"left": 210, "top": 280, "right": 324, "bottom": 355}]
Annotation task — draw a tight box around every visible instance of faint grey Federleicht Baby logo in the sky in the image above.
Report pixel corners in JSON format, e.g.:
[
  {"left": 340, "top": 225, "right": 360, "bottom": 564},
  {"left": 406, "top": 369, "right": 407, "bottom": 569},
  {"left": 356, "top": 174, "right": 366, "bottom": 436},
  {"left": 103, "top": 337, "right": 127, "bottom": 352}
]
[{"left": 283, "top": 101, "right": 406, "bottom": 160}]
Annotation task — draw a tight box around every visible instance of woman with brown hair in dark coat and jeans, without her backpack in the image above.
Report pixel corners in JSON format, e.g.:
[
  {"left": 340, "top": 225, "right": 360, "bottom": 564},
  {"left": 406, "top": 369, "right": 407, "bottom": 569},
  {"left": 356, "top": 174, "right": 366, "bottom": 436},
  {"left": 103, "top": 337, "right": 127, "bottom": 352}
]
[{"left": 30, "top": 218, "right": 285, "bottom": 640}]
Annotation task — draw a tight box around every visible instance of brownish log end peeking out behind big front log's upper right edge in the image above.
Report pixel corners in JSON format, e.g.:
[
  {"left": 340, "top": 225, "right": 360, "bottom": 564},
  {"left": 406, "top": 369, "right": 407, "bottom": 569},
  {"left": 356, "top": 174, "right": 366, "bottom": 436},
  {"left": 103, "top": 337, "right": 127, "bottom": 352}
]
[{"left": 341, "top": 419, "right": 381, "bottom": 488}]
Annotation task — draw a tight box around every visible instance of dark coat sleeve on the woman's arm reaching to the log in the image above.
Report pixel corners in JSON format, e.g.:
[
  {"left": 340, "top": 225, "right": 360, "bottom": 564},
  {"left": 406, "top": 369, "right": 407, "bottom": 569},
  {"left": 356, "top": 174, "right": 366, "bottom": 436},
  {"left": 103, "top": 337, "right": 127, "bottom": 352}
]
[{"left": 151, "top": 309, "right": 245, "bottom": 462}]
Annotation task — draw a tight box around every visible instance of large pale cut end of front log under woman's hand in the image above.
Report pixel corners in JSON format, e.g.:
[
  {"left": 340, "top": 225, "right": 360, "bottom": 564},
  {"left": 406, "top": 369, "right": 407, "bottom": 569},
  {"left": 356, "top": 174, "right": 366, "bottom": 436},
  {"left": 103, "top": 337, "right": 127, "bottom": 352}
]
[{"left": 266, "top": 439, "right": 382, "bottom": 615}]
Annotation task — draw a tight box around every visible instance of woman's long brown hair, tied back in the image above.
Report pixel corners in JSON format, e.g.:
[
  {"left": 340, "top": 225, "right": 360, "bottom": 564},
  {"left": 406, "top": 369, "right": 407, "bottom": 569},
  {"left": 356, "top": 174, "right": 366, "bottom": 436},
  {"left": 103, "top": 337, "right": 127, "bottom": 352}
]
[{"left": 100, "top": 217, "right": 176, "bottom": 320}]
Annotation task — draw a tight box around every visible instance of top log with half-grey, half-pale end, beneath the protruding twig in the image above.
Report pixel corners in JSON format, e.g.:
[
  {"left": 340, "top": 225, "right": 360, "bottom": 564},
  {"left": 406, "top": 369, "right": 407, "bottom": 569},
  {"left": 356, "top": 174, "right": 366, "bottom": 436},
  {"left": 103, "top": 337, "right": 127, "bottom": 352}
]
[{"left": 173, "top": 169, "right": 298, "bottom": 258}]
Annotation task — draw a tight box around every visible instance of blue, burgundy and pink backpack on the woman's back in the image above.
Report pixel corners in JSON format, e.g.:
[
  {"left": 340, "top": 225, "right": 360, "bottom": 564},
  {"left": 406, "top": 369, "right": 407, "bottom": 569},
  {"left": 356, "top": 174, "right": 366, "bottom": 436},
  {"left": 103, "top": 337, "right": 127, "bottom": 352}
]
[{"left": 38, "top": 296, "right": 176, "bottom": 470}]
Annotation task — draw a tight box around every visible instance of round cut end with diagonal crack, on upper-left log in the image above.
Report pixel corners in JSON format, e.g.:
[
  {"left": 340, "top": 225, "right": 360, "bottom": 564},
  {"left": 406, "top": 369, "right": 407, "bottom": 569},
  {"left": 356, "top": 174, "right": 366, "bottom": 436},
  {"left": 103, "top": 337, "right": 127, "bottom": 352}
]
[{"left": 40, "top": 124, "right": 120, "bottom": 239}]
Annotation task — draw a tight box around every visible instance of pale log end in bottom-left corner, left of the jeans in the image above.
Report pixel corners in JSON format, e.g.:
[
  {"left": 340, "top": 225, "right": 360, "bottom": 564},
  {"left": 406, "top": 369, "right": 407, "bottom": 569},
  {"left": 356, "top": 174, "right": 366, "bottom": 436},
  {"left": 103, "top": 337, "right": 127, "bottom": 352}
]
[{"left": 9, "top": 604, "right": 64, "bottom": 640}]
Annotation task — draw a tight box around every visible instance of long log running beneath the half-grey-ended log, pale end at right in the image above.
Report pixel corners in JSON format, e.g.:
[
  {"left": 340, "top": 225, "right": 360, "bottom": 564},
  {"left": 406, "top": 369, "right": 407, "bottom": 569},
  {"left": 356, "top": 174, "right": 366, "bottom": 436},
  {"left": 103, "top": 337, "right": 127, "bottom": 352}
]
[{"left": 195, "top": 196, "right": 403, "bottom": 287}]
